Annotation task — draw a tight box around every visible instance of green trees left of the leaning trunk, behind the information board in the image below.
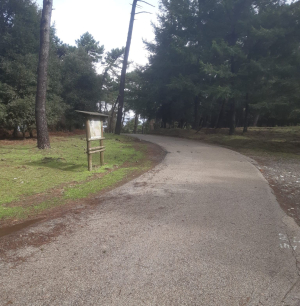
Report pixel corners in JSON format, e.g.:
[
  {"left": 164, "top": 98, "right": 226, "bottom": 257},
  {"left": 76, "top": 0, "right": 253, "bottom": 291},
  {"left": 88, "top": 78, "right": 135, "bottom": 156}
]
[{"left": 0, "top": 0, "right": 124, "bottom": 137}]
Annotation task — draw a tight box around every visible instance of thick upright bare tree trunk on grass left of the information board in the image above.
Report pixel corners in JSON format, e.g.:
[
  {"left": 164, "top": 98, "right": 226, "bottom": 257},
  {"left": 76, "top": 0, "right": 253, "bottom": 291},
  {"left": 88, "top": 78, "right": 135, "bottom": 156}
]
[{"left": 35, "top": 0, "right": 53, "bottom": 149}]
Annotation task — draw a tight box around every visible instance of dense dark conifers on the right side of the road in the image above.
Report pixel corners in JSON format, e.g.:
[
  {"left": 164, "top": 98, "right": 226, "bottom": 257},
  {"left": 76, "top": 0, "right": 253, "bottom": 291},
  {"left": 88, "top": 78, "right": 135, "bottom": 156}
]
[{"left": 126, "top": 0, "right": 300, "bottom": 134}]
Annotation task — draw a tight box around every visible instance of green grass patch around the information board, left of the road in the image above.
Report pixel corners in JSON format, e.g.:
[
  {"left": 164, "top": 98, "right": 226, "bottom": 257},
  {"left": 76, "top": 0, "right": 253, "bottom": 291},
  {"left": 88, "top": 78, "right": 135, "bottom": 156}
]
[{"left": 0, "top": 134, "right": 151, "bottom": 224}]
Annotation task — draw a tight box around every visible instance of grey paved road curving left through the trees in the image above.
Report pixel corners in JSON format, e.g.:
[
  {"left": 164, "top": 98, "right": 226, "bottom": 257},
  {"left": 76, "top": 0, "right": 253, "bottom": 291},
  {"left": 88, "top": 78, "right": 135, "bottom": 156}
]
[{"left": 0, "top": 136, "right": 300, "bottom": 306}]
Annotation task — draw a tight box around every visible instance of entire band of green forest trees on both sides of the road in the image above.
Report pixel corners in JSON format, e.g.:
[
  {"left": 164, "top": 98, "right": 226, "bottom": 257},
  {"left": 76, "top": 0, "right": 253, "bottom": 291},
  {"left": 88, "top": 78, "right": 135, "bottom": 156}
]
[{"left": 0, "top": 0, "right": 300, "bottom": 137}]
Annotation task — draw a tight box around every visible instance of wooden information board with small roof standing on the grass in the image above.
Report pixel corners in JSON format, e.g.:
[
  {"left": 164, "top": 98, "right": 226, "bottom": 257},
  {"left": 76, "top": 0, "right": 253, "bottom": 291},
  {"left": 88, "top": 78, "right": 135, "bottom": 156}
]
[{"left": 76, "top": 111, "right": 108, "bottom": 171}]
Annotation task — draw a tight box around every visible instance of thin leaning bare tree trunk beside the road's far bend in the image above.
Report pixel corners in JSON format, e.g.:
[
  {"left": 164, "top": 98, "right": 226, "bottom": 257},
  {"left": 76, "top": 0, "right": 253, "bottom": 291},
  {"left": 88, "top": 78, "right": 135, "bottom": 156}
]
[{"left": 115, "top": 0, "right": 138, "bottom": 135}]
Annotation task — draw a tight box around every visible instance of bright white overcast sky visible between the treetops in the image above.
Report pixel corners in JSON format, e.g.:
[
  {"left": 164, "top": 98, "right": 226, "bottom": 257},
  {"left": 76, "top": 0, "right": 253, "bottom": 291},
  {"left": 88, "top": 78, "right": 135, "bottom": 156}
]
[{"left": 36, "top": 0, "right": 159, "bottom": 64}]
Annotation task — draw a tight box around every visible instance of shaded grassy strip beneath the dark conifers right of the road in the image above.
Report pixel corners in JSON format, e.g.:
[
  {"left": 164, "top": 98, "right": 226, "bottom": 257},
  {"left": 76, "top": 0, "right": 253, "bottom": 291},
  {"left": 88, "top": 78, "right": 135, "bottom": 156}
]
[{"left": 154, "top": 126, "right": 300, "bottom": 159}]
